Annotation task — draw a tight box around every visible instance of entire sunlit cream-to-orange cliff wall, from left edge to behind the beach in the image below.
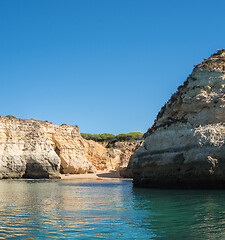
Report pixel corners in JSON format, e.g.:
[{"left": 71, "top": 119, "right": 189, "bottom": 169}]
[{"left": 0, "top": 117, "right": 141, "bottom": 178}]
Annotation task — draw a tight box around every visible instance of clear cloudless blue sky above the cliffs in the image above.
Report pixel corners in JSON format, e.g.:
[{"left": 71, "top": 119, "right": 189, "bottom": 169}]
[{"left": 0, "top": 0, "right": 225, "bottom": 134}]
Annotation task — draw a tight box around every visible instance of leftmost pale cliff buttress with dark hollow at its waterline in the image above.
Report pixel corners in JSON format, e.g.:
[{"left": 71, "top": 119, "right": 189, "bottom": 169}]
[{"left": 0, "top": 117, "right": 60, "bottom": 178}]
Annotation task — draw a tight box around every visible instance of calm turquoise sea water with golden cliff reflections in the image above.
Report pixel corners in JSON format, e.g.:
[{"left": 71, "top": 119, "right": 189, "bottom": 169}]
[{"left": 0, "top": 180, "right": 225, "bottom": 240}]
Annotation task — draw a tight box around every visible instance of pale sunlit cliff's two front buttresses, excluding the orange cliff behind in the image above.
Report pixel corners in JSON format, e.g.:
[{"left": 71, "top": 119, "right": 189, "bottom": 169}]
[{"left": 0, "top": 117, "right": 96, "bottom": 178}]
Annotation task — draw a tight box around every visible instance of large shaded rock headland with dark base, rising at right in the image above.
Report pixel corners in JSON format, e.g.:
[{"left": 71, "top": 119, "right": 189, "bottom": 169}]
[{"left": 132, "top": 50, "right": 225, "bottom": 188}]
